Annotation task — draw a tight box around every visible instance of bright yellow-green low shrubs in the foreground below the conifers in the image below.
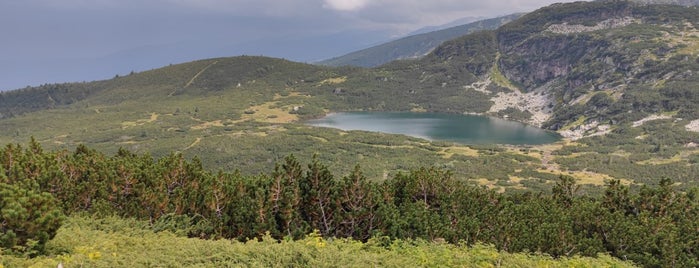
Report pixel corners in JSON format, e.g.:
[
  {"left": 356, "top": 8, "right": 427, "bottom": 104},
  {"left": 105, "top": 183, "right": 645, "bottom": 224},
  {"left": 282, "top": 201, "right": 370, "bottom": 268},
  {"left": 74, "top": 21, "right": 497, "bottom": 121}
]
[{"left": 0, "top": 217, "right": 633, "bottom": 267}]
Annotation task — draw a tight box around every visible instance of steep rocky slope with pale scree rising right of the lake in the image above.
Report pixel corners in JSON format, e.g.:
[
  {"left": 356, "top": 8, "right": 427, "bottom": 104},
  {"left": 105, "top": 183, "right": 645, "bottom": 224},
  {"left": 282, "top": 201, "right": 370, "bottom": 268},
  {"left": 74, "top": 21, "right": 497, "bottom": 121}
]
[{"left": 456, "top": 1, "right": 699, "bottom": 138}]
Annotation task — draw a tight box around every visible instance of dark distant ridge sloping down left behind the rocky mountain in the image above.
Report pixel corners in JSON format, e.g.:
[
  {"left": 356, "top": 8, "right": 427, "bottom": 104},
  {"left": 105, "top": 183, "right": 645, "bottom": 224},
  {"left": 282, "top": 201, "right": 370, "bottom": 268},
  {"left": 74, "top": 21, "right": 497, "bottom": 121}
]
[{"left": 318, "top": 14, "right": 522, "bottom": 67}]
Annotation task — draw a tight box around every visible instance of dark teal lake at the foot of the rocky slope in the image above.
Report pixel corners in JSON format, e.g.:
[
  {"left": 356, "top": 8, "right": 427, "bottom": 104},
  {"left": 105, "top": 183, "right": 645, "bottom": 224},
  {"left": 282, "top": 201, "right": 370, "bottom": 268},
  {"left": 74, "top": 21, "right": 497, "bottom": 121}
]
[{"left": 307, "top": 112, "right": 561, "bottom": 145}]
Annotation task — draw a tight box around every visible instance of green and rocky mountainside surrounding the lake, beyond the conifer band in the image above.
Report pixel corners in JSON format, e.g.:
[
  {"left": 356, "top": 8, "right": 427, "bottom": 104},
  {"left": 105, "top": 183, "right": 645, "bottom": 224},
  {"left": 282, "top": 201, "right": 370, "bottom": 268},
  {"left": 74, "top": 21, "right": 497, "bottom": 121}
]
[{"left": 0, "top": 1, "right": 699, "bottom": 188}]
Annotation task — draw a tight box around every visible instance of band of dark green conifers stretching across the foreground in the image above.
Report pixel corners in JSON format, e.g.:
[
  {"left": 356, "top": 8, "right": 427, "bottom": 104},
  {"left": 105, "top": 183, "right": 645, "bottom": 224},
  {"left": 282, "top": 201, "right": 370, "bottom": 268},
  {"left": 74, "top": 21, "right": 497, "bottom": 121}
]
[{"left": 0, "top": 139, "right": 699, "bottom": 267}]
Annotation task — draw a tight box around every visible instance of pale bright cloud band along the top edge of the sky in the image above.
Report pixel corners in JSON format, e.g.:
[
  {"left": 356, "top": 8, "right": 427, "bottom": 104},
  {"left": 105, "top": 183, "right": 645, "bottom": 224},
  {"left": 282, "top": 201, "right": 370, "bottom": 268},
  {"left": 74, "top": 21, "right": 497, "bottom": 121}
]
[{"left": 12, "top": 0, "right": 572, "bottom": 32}]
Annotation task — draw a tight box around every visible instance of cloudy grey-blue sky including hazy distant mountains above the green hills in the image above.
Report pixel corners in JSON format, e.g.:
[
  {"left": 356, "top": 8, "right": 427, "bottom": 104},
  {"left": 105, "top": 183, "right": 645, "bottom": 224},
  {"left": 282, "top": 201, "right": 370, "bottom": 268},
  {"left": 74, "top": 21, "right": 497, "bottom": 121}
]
[{"left": 0, "top": 0, "right": 571, "bottom": 90}]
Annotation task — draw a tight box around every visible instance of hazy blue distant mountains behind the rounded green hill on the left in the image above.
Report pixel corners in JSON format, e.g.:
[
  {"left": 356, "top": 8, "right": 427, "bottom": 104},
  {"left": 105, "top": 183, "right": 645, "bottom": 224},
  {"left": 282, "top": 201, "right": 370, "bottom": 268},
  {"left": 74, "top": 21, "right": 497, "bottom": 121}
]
[{"left": 0, "top": 27, "right": 390, "bottom": 91}]
